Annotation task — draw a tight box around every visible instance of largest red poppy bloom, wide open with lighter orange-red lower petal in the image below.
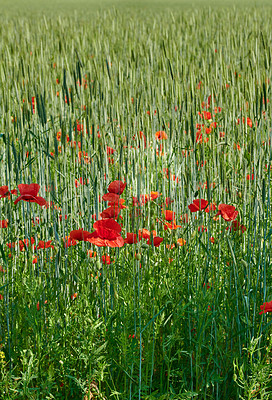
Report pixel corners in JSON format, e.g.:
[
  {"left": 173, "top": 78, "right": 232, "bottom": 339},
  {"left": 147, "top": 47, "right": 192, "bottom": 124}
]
[{"left": 87, "top": 218, "right": 125, "bottom": 247}]
